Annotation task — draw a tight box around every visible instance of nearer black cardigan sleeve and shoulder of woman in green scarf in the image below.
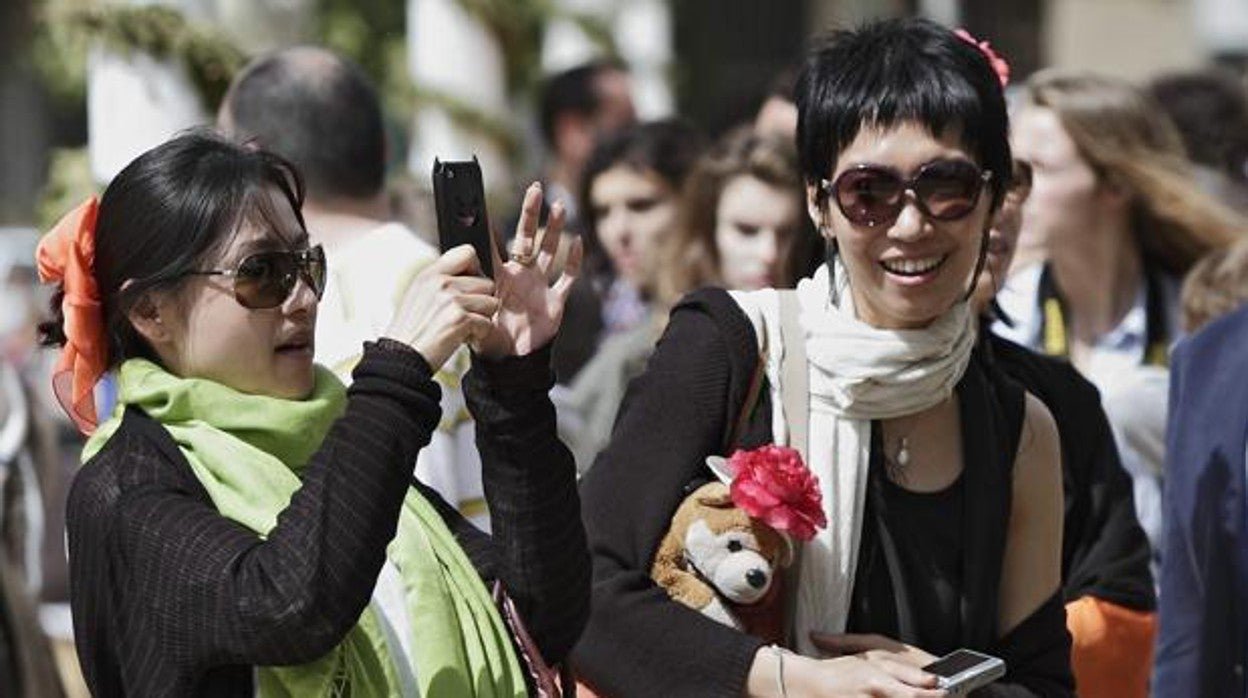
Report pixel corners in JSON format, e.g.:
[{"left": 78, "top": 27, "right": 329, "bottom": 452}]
[{"left": 67, "top": 342, "right": 441, "bottom": 696}]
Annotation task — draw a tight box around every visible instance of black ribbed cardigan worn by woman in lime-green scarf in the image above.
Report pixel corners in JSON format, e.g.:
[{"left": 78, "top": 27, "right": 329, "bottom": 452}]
[{"left": 67, "top": 340, "right": 589, "bottom": 697}]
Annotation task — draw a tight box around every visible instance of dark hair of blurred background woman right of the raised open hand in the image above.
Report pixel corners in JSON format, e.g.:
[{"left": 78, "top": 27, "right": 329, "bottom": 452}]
[{"left": 579, "top": 119, "right": 706, "bottom": 277}]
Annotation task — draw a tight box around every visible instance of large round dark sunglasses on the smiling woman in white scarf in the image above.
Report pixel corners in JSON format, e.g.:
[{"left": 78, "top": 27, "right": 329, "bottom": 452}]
[{"left": 820, "top": 160, "right": 992, "bottom": 227}]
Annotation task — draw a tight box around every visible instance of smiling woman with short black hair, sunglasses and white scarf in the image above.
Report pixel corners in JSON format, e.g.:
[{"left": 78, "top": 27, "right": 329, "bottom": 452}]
[{"left": 573, "top": 20, "right": 1073, "bottom": 697}]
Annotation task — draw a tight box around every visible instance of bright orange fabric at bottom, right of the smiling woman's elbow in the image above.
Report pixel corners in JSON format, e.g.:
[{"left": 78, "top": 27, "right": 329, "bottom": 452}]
[{"left": 1066, "top": 597, "right": 1157, "bottom": 698}]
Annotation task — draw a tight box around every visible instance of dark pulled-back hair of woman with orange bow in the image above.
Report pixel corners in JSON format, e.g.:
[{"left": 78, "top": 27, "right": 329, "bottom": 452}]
[{"left": 39, "top": 131, "right": 303, "bottom": 367}]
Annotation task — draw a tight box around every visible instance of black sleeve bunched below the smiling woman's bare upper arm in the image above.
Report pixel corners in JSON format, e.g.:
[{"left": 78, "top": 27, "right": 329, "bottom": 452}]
[{"left": 975, "top": 593, "right": 1075, "bottom": 698}]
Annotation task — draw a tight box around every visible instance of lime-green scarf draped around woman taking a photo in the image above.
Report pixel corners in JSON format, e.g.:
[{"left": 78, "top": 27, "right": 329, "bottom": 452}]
[{"left": 82, "top": 360, "right": 525, "bottom": 698}]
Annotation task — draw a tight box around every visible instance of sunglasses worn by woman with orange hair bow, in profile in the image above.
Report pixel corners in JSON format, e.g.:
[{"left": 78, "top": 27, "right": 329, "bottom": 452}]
[{"left": 187, "top": 245, "right": 326, "bottom": 310}]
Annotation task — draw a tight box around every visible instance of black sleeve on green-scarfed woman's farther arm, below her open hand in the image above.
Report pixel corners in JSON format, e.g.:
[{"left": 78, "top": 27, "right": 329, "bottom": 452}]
[{"left": 463, "top": 345, "right": 590, "bottom": 664}]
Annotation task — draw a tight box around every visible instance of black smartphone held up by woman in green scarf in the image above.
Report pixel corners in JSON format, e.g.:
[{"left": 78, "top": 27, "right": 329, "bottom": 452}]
[{"left": 433, "top": 155, "right": 494, "bottom": 278}]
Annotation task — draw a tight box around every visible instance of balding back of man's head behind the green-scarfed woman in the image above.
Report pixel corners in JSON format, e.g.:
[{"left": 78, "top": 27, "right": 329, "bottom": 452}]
[{"left": 225, "top": 46, "right": 386, "bottom": 199}]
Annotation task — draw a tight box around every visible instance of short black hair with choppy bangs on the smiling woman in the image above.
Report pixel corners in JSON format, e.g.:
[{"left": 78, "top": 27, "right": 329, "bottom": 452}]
[{"left": 796, "top": 19, "right": 1011, "bottom": 210}]
